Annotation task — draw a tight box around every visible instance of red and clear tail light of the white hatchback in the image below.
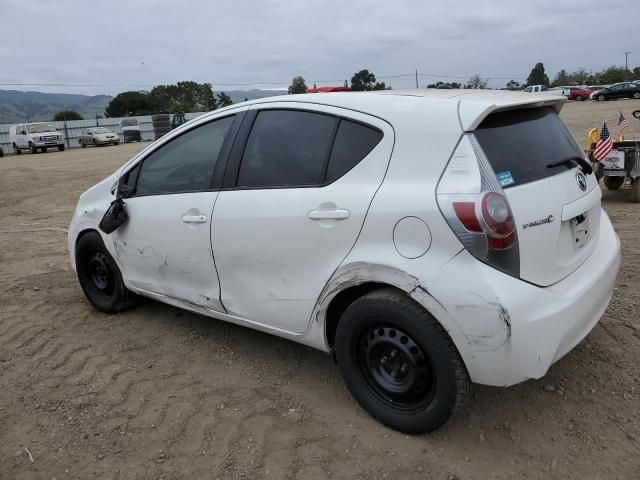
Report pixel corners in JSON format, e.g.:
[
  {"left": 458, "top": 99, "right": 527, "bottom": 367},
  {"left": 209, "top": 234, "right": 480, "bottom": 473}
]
[{"left": 437, "top": 134, "right": 520, "bottom": 277}]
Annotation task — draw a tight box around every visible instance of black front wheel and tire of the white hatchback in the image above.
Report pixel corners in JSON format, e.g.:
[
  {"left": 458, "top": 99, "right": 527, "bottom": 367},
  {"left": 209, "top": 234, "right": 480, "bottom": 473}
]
[{"left": 76, "top": 232, "right": 135, "bottom": 313}]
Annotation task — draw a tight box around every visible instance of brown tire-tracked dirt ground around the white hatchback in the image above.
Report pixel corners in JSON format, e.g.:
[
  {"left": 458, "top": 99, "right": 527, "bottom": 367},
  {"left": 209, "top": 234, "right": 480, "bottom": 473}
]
[{"left": 0, "top": 101, "right": 640, "bottom": 480}]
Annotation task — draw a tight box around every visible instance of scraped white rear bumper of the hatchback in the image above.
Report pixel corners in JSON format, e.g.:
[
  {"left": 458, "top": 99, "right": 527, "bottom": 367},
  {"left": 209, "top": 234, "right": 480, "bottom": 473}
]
[{"left": 428, "top": 211, "right": 620, "bottom": 386}]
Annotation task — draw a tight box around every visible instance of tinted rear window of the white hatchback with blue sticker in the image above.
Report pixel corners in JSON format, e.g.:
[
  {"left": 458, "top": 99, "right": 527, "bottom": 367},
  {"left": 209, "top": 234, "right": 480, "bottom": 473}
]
[{"left": 474, "top": 108, "right": 584, "bottom": 188}]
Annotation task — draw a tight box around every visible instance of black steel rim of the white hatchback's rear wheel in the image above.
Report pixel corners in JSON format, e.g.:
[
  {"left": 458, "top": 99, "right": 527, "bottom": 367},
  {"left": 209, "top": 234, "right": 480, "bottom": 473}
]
[{"left": 357, "top": 324, "right": 436, "bottom": 413}]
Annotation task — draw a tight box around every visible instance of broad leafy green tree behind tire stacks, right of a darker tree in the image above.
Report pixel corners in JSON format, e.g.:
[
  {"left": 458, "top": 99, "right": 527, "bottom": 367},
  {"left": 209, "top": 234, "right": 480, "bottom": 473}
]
[{"left": 149, "top": 81, "right": 217, "bottom": 113}]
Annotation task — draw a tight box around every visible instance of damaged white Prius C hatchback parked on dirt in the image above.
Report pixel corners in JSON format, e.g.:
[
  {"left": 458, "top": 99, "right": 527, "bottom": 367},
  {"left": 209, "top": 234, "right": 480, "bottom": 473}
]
[{"left": 69, "top": 90, "right": 620, "bottom": 433}]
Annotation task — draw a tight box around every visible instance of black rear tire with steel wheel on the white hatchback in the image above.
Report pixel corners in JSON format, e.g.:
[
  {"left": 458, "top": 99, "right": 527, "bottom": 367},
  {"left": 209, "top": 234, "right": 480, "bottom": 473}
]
[{"left": 335, "top": 289, "right": 469, "bottom": 434}]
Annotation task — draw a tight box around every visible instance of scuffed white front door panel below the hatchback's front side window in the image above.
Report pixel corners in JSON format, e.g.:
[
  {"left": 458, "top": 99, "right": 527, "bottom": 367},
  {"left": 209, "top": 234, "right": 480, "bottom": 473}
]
[{"left": 111, "top": 192, "right": 222, "bottom": 310}]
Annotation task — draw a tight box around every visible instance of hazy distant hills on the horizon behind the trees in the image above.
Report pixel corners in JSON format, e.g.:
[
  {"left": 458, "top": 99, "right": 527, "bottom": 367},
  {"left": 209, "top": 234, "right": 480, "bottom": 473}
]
[{"left": 0, "top": 90, "right": 286, "bottom": 123}]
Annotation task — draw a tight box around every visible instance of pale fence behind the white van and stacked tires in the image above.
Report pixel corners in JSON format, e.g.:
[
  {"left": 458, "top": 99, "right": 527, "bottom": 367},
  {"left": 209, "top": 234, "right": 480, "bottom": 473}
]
[{"left": 0, "top": 112, "right": 204, "bottom": 155}]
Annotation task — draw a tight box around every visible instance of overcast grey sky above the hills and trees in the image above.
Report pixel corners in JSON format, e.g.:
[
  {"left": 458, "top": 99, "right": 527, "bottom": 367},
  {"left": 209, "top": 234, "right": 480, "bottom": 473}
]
[{"left": 0, "top": 0, "right": 640, "bottom": 95}]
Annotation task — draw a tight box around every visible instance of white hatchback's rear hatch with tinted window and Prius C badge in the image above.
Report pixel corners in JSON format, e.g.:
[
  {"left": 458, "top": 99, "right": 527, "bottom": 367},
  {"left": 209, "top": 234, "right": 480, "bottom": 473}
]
[{"left": 474, "top": 107, "right": 601, "bottom": 286}]
